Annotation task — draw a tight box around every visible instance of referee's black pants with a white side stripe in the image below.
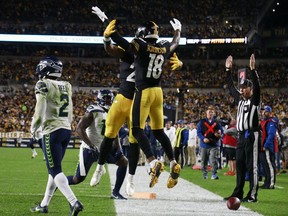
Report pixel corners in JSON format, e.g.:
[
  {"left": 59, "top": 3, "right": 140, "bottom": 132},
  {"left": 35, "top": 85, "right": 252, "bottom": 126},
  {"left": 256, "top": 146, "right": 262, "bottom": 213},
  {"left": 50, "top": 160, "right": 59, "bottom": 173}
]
[{"left": 232, "top": 131, "right": 259, "bottom": 200}]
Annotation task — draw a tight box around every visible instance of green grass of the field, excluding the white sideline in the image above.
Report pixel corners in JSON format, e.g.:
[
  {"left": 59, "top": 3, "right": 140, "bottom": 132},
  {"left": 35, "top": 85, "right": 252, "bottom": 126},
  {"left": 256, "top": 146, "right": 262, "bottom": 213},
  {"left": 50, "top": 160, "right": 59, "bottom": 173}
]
[{"left": 0, "top": 147, "right": 288, "bottom": 216}]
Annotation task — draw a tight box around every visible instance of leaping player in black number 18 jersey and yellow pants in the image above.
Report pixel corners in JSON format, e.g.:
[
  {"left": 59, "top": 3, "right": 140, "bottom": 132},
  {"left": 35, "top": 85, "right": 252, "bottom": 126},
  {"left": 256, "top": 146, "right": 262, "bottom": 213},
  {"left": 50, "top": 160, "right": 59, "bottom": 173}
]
[{"left": 105, "top": 19, "right": 182, "bottom": 188}]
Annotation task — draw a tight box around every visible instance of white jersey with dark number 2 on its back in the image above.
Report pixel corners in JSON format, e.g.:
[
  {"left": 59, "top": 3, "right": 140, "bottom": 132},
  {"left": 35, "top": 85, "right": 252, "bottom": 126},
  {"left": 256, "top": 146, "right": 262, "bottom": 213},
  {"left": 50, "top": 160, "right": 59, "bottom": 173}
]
[{"left": 31, "top": 78, "right": 73, "bottom": 135}]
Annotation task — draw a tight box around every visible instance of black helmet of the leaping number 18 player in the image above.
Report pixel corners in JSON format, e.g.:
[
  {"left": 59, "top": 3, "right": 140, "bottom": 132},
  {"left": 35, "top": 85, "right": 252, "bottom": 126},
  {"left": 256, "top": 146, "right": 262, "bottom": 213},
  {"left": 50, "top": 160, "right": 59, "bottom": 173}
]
[{"left": 135, "top": 21, "right": 159, "bottom": 39}]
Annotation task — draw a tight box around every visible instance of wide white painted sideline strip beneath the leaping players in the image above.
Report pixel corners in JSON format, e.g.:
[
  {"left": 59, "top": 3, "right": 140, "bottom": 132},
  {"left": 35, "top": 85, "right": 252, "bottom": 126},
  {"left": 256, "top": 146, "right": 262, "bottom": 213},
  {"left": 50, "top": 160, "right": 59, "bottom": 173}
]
[{"left": 108, "top": 164, "right": 260, "bottom": 216}]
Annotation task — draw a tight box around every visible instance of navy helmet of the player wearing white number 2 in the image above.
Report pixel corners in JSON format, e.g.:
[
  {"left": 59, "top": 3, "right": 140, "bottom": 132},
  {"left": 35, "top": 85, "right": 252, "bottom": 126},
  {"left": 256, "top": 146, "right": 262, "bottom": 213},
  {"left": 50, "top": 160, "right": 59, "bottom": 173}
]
[{"left": 36, "top": 56, "right": 63, "bottom": 78}]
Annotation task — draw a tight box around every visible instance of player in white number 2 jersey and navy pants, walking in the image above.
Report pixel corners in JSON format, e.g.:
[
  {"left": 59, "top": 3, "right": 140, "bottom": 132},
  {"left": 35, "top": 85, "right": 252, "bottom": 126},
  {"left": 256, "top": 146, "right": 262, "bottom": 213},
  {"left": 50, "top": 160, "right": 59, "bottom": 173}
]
[{"left": 31, "top": 57, "right": 83, "bottom": 215}]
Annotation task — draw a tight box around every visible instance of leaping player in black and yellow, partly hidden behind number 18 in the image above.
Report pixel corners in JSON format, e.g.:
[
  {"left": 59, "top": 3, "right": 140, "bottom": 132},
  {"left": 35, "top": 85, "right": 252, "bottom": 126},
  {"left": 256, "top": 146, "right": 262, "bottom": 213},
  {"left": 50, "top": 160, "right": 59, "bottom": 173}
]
[{"left": 91, "top": 7, "right": 182, "bottom": 196}]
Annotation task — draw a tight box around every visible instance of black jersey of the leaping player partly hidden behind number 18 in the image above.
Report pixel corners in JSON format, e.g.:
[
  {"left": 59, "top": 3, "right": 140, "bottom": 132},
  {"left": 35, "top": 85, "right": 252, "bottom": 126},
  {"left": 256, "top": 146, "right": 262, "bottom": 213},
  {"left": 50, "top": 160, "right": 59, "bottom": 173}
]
[{"left": 119, "top": 52, "right": 135, "bottom": 100}]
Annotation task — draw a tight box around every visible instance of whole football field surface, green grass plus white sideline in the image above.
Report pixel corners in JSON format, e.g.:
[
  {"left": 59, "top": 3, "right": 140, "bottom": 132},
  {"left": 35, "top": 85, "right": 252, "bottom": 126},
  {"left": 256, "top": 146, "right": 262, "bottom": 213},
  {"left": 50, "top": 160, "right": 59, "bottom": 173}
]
[{"left": 0, "top": 147, "right": 288, "bottom": 216}]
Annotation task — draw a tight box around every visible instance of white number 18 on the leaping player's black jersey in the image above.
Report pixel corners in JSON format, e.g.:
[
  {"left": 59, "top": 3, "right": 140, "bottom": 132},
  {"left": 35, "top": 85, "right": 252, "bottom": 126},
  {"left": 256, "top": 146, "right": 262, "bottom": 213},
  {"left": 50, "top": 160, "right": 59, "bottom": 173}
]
[{"left": 146, "top": 53, "right": 164, "bottom": 79}]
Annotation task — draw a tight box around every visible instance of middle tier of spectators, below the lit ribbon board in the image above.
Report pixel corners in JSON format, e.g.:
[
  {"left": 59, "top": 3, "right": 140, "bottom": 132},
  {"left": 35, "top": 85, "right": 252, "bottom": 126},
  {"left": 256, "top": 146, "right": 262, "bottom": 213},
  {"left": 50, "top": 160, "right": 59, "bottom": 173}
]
[{"left": 0, "top": 57, "right": 288, "bottom": 88}]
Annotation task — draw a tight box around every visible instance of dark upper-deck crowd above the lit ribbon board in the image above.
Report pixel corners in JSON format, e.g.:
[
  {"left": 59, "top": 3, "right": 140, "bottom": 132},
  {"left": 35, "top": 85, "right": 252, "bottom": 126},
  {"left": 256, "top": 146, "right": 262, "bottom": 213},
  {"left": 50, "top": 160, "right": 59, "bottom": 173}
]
[{"left": 0, "top": 0, "right": 267, "bottom": 38}]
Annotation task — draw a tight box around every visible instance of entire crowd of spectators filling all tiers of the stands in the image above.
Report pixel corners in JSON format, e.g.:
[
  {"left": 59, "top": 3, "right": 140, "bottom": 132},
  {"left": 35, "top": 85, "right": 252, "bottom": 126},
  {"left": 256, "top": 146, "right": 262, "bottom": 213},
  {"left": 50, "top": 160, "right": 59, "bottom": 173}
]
[{"left": 0, "top": 0, "right": 288, "bottom": 138}]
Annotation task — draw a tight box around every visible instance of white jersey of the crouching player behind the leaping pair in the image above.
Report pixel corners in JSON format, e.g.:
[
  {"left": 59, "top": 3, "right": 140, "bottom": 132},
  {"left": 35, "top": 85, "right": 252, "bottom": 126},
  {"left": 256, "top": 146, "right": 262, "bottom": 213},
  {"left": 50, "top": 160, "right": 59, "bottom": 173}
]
[{"left": 82, "top": 104, "right": 107, "bottom": 149}]
